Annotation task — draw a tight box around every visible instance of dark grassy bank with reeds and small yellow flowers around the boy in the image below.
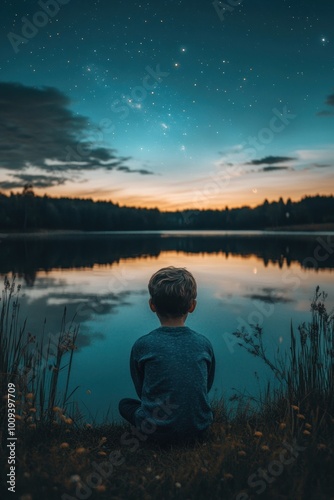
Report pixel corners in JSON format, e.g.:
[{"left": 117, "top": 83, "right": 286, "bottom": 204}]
[{"left": 0, "top": 280, "right": 334, "bottom": 500}]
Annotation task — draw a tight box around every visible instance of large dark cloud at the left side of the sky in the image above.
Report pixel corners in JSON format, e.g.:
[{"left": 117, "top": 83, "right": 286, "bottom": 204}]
[{"left": 0, "top": 82, "right": 153, "bottom": 187}]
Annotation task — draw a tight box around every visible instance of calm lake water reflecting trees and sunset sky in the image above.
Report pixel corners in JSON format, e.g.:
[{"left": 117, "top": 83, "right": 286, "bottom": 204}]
[{"left": 0, "top": 232, "right": 334, "bottom": 422}]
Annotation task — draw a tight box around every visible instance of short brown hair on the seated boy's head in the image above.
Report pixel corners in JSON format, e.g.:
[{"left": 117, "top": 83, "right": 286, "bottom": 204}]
[{"left": 148, "top": 266, "right": 197, "bottom": 317}]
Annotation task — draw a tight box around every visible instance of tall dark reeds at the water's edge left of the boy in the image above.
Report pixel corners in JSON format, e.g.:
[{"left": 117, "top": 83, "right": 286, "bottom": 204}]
[{"left": 0, "top": 276, "right": 79, "bottom": 431}]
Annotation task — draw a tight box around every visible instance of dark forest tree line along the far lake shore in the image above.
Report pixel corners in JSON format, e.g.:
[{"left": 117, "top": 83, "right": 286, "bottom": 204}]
[{"left": 0, "top": 186, "right": 334, "bottom": 231}]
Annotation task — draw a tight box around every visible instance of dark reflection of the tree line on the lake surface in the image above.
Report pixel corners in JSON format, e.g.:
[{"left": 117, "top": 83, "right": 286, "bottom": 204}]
[{"left": 0, "top": 233, "right": 334, "bottom": 284}]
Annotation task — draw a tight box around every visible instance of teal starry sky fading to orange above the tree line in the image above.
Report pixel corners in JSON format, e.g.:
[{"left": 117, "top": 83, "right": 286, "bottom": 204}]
[{"left": 0, "top": 0, "right": 334, "bottom": 210}]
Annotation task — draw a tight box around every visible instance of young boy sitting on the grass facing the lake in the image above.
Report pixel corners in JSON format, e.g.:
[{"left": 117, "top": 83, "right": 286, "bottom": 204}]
[{"left": 119, "top": 267, "right": 215, "bottom": 441}]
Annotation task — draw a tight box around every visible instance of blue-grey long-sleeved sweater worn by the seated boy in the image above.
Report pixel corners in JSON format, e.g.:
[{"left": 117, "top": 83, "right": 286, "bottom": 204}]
[{"left": 130, "top": 326, "right": 215, "bottom": 435}]
